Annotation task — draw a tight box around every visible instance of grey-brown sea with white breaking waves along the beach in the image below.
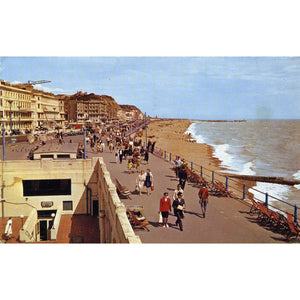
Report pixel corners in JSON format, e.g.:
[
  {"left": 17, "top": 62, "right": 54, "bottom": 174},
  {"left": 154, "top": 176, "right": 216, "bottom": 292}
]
[{"left": 186, "top": 120, "right": 300, "bottom": 211}]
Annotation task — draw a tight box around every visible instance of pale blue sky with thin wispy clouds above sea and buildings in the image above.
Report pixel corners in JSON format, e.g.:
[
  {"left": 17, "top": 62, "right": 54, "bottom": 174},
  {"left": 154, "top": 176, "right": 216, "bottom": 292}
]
[{"left": 0, "top": 56, "right": 300, "bottom": 119}]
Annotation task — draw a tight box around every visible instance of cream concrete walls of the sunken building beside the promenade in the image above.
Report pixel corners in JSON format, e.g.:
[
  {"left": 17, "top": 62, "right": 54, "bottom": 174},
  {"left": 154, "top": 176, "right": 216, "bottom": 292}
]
[{"left": 0, "top": 158, "right": 141, "bottom": 243}]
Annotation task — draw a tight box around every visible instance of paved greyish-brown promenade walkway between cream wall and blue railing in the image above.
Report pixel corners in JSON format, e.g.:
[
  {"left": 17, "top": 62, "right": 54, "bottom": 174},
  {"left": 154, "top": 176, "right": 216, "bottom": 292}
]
[{"left": 98, "top": 147, "right": 286, "bottom": 243}]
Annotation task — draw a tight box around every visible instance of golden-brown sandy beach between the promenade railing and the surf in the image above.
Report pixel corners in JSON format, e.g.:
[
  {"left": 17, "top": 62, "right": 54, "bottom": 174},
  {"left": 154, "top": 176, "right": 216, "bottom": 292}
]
[{"left": 143, "top": 119, "right": 256, "bottom": 197}]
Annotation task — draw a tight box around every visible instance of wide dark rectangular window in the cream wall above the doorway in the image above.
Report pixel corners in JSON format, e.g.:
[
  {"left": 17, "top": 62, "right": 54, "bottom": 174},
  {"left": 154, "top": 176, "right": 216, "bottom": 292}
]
[{"left": 23, "top": 179, "right": 71, "bottom": 196}]
